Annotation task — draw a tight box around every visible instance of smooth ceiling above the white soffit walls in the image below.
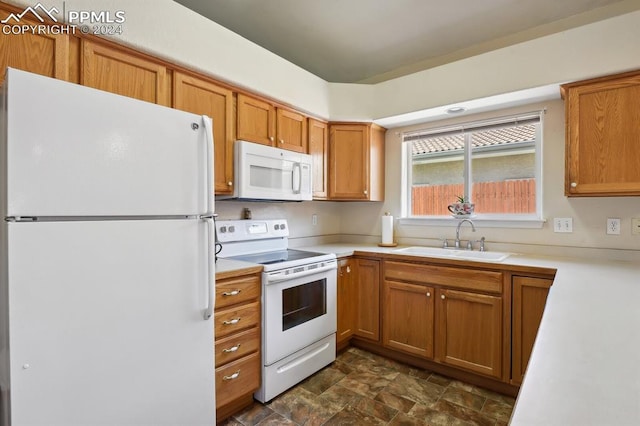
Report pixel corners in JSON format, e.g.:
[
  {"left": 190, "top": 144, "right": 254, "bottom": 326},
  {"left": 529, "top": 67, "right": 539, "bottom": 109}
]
[{"left": 175, "top": 0, "right": 640, "bottom": 83}]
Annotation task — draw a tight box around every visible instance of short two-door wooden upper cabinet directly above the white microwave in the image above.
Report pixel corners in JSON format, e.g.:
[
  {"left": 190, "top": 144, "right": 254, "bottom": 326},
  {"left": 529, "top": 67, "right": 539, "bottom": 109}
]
[{"left": 237, "top": 93, "right": 307, "bottom": 153}]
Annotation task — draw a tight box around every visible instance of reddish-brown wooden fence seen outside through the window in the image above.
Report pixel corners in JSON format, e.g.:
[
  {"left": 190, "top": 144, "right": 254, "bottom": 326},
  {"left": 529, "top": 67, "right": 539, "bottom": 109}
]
[{"left": 411, "top": 179, "right": 536, "bottom": 216}]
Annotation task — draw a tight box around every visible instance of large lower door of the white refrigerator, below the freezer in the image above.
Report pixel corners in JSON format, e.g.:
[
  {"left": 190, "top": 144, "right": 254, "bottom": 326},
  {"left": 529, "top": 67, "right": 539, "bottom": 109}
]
[{"left": 2, "top": 220, "right": 215, "bottom": 425}]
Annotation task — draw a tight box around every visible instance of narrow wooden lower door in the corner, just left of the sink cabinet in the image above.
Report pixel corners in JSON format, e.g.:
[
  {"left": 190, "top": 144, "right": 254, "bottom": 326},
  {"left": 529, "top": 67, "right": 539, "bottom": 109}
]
[{"left": 354, "top": 259, "right": 380, "bottom": 342}]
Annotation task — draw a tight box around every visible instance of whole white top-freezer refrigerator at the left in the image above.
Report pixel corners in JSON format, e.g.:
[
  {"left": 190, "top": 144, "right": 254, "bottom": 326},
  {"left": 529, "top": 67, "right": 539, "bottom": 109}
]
[{"left": 0, "top": 69, "right": 215, "bottom": 425}]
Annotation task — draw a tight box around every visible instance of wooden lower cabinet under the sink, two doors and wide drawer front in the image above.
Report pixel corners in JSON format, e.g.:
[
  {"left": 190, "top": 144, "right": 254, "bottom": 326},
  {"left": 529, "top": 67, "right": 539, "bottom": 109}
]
[{"left": 382, "top": 261, "right": 504, "bottom": 379}]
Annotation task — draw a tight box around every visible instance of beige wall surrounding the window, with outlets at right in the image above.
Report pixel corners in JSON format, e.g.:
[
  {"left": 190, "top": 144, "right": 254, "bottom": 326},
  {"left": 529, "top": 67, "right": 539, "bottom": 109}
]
[{"left": 341, "top": 100, "right": 640, "bottom": 252}]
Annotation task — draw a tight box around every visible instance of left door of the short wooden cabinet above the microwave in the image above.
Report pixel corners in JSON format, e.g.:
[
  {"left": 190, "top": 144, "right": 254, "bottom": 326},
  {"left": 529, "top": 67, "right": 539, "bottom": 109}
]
[{"left": 237, "top": 93, "right": 276, "bottom": 146}]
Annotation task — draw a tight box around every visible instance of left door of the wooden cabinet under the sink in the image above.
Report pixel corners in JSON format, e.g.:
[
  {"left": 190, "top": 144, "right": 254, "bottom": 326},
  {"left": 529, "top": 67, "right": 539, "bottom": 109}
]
[{"left": 382, "top": 280, "right": 435, "bottom": 358}]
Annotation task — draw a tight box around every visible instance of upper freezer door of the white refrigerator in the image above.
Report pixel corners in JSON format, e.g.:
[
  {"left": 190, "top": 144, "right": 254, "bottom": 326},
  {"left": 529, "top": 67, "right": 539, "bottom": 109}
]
[{"left": 2, "top": 69, "right": 213, "bottom": 216}]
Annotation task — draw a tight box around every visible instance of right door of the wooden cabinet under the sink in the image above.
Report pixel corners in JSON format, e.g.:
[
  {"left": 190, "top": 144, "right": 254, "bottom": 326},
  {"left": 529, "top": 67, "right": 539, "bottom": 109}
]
[{"left": 436, "top": 289, "right": 502, "bottom": 379}]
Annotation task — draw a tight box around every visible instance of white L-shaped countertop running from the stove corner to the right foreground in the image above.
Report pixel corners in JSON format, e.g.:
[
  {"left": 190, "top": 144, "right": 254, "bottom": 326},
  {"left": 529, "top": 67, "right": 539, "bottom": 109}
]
[{"left": 299, "top": 244, "right": 640, "bottom": 426}]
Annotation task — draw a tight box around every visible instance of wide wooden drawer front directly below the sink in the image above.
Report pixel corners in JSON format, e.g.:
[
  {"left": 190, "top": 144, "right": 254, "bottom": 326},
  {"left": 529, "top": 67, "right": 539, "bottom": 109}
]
[{"left": 384, "top": 261, "right": 502, "bottom": 293}]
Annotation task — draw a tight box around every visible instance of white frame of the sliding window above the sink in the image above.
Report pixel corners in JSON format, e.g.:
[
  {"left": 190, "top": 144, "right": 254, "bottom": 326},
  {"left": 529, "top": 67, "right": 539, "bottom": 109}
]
[{"left": 399, "top": 109, "right": 546, "bottom": 228}]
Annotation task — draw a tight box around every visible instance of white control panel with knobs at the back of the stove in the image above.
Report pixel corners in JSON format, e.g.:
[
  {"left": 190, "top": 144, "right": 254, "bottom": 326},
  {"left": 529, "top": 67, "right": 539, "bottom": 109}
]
[{"left": 216, "top": 219, "right": 289, "bottom": 242}]
